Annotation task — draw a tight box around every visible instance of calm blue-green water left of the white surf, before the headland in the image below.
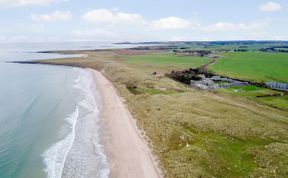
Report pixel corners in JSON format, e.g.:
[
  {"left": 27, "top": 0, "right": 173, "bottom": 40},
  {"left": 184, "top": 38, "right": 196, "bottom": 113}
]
[{"left": 0, "top": 64, "right": 79, "bottom": 178}]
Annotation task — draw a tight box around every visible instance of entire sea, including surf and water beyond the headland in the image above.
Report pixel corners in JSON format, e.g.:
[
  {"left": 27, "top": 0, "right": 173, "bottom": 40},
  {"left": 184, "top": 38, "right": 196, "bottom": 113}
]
[{"left": 0, "top": 42, "right": 138, "bottom": 178}]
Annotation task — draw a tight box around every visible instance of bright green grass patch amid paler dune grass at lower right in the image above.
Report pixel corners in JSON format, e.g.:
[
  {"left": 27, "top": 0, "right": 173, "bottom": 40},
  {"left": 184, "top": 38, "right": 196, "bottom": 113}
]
[{"left": 180, "top": 125, "right": 271, "bottom": 177}]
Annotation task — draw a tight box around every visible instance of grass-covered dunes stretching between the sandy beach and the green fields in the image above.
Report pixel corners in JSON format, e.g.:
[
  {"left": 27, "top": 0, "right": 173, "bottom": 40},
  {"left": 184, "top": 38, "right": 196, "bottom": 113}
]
[{"left": 31, "top": 51, "right": 288, "bottom": 178}]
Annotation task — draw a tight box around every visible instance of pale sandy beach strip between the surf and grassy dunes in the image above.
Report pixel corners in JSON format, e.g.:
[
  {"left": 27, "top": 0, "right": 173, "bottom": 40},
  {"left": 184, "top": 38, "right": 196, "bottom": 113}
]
[{"left": 87, "top": 69, "right": 163, "bottom": 178}]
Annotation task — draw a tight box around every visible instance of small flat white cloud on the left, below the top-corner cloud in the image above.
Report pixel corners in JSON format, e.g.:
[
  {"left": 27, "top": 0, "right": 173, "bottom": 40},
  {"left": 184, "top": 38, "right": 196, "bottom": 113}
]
[{"left": 30, "top": 11, "right": 71, "bottom": 22}]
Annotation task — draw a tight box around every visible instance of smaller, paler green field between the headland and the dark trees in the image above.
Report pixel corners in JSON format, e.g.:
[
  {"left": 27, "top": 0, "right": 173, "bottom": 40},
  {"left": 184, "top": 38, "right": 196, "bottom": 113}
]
[{"left": 124, "top": 53, "right": 210, "bottom": 72}]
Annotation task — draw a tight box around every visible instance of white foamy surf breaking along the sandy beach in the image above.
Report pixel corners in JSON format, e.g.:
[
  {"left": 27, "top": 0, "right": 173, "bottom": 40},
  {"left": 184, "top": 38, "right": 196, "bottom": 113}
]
[{"left": 43, "top": 69, "right": 110, "bottom": 178}]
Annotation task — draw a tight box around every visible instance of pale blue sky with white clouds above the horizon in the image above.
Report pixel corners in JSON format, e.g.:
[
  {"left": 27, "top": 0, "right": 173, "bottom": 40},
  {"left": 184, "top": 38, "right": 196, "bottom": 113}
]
[{"left": 0, "top": 0, "right": 288, "bottom": 42}]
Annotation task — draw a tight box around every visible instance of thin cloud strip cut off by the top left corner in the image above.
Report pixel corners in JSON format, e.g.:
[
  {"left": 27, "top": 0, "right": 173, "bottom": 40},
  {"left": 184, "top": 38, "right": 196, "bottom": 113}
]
[{"left": 0, "top": 0, "right": 69, "bottom": 7}]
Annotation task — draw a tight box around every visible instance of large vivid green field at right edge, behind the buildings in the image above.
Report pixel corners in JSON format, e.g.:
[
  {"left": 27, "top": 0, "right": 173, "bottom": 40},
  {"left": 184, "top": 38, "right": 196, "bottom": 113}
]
[{"left": 209, "top": 52, "right": 288, "bottom": 83}]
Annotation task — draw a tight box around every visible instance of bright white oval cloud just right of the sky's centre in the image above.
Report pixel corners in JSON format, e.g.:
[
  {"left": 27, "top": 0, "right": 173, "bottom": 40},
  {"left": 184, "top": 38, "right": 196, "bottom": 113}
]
[{"left": 150, "top": 16, "right": 192, "bottom": 30}]
